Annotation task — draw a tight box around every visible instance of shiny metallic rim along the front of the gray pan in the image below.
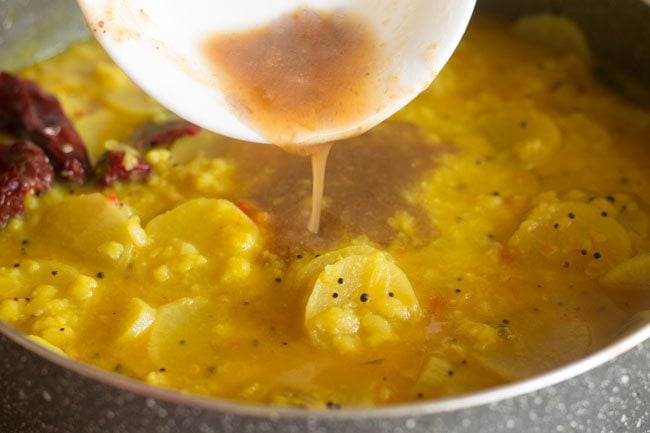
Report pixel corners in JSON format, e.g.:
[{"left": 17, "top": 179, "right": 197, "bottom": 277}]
[{"left": 0, "top": 321, "right": 650, "bottom": 420}]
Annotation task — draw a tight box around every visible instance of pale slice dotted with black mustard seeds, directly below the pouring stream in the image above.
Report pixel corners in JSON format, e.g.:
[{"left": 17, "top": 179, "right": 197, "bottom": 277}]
[{"left": 305, "top": 250, "right": 421, "bottom": 352}]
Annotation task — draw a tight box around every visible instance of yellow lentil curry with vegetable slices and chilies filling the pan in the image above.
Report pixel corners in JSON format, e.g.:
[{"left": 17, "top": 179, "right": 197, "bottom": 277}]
[{"left": 0, "top": 18, "right": 650, "bottom": 409}]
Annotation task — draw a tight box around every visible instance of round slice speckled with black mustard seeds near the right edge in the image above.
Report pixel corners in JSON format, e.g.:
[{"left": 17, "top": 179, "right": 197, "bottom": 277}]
[{"left": 508, "top": 202, "right": 632, "bottom": 276}]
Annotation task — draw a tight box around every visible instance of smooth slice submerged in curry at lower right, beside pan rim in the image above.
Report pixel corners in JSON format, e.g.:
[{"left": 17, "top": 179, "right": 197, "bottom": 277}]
[{"left": 468, "top": 308, "right": 591, "bottom": 380}]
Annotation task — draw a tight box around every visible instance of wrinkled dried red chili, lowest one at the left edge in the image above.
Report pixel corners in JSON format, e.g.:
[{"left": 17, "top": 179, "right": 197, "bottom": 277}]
[{"left": 0, "top": 140, "right": 54, "bottom": 227}]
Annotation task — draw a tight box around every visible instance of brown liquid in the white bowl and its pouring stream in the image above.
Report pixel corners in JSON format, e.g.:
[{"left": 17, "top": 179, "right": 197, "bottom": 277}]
[{"left": 204, "top": 9, "right": 379, "bottom": 233}]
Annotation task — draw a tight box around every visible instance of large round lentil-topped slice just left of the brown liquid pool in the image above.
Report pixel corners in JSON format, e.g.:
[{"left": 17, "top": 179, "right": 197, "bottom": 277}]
[{"left": 142, "top": 199, "right": 260, "bottom": 290}]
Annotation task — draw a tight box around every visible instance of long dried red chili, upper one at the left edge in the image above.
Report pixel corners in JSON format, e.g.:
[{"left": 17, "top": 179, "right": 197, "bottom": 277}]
[{"left": 0, "top": 71, "right": 91, "bottom": 183}]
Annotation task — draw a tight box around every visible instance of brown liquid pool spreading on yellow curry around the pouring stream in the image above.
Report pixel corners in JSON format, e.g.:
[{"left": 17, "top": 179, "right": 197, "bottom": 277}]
[{"left": 174, "top": 121, "right": 446, "bottom": 258}]
